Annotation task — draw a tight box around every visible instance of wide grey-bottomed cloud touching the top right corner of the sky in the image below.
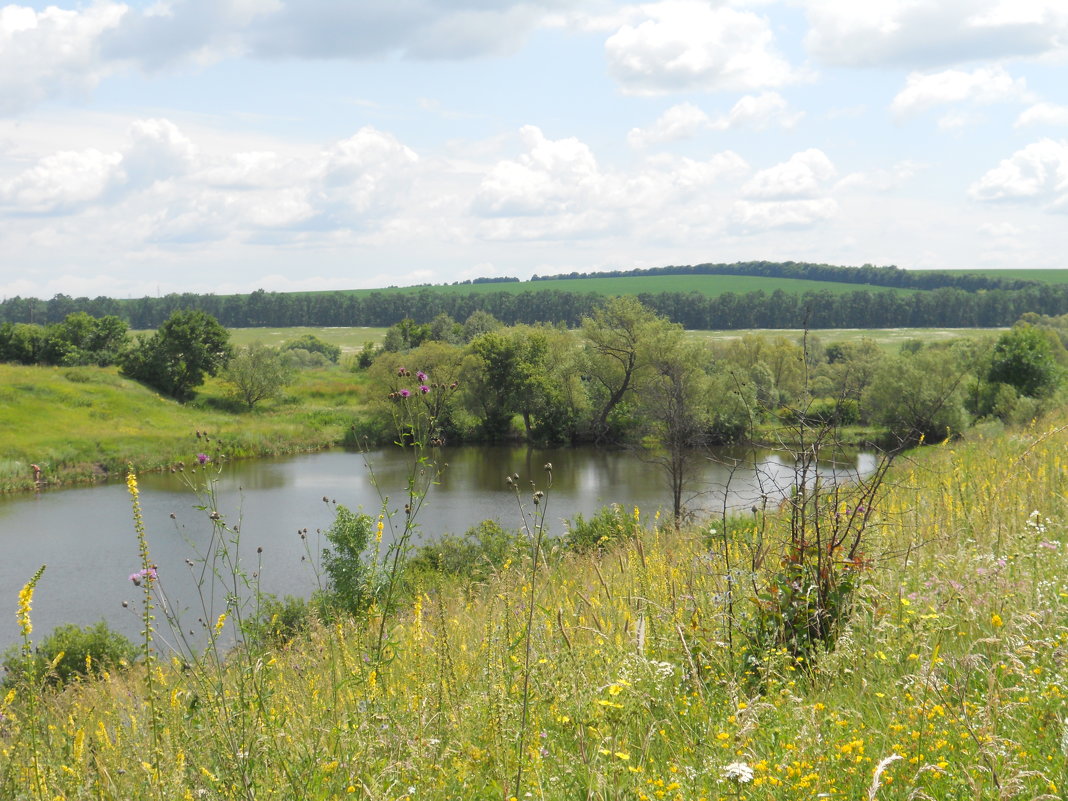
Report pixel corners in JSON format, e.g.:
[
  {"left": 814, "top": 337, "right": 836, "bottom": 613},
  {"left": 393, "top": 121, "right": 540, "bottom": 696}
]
[{"left": 804, "top": 0, "right": 1068, "bottom": 67}]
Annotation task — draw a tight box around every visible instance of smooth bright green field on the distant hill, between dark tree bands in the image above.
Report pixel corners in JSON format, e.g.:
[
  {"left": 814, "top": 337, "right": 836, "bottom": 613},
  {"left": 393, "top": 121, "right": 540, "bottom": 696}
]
[{"left": 313, "top": 276, "right": 916, "bottom": 298}]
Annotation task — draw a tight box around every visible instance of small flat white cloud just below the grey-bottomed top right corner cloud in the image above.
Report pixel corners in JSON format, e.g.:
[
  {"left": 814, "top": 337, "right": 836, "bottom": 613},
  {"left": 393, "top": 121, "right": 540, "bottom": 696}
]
[{"left": 891, "top": 65, "right": 1027, "bottom": 115}]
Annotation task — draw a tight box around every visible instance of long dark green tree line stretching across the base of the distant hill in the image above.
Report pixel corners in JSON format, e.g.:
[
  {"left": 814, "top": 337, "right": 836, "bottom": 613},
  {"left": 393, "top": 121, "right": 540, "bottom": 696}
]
[{"left": 0, "top": 284, "right": 1068, "bottom": 330}]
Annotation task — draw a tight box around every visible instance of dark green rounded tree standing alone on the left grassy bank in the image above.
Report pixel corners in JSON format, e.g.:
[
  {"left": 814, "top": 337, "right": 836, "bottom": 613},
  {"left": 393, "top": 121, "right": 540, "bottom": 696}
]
[{"left": 121, "top": 311, "right": 231, "bottom": 401}]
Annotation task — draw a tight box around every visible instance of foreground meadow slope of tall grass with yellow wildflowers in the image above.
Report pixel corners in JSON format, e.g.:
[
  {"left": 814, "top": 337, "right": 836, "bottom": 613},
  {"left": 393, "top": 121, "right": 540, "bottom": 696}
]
[{"left": 0, "top": 407, "right": 1068, "bottom": 801}]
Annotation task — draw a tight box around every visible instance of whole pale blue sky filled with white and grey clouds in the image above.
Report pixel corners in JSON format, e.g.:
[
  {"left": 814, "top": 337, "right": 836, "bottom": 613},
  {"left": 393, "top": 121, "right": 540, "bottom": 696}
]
[{"left": 0, "top": 0, "right": 1068, "bottom": 298}]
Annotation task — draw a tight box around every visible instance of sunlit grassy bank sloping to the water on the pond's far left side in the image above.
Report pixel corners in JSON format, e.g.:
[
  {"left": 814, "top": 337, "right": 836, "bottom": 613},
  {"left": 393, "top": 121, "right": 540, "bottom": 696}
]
[{"left": 0, "top": 364, "right": 365, "bottom": 492}]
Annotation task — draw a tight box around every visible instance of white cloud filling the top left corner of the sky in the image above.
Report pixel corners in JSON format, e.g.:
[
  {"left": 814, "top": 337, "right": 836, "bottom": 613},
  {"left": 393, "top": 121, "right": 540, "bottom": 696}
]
[{"left": 0, "top": 1, "right": 127, "bottom": 114}]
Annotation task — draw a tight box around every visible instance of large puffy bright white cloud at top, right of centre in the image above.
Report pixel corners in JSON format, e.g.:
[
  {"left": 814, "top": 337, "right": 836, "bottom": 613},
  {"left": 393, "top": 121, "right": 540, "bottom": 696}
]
[{"left": 604, "top": 0, "right": 797, "bottom": 95}]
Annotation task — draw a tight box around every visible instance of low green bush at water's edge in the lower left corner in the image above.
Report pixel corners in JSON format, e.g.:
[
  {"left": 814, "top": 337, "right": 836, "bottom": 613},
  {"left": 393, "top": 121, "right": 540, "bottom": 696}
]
[{"left": 2, "top": 621, "right": 139, "bottom": 687}]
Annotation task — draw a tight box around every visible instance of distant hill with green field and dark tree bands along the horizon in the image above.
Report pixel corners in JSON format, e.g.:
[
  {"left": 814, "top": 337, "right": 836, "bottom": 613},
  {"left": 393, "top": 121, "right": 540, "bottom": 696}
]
[{"left": 0, "top": 262, "right": 1068, "bottom": 330}]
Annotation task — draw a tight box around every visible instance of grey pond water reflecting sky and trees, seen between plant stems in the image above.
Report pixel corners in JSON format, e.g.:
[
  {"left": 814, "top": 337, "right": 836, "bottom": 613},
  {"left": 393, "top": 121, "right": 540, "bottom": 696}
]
[{"left": 0, "top": 445, "right": 877, "bottom": 649}]
